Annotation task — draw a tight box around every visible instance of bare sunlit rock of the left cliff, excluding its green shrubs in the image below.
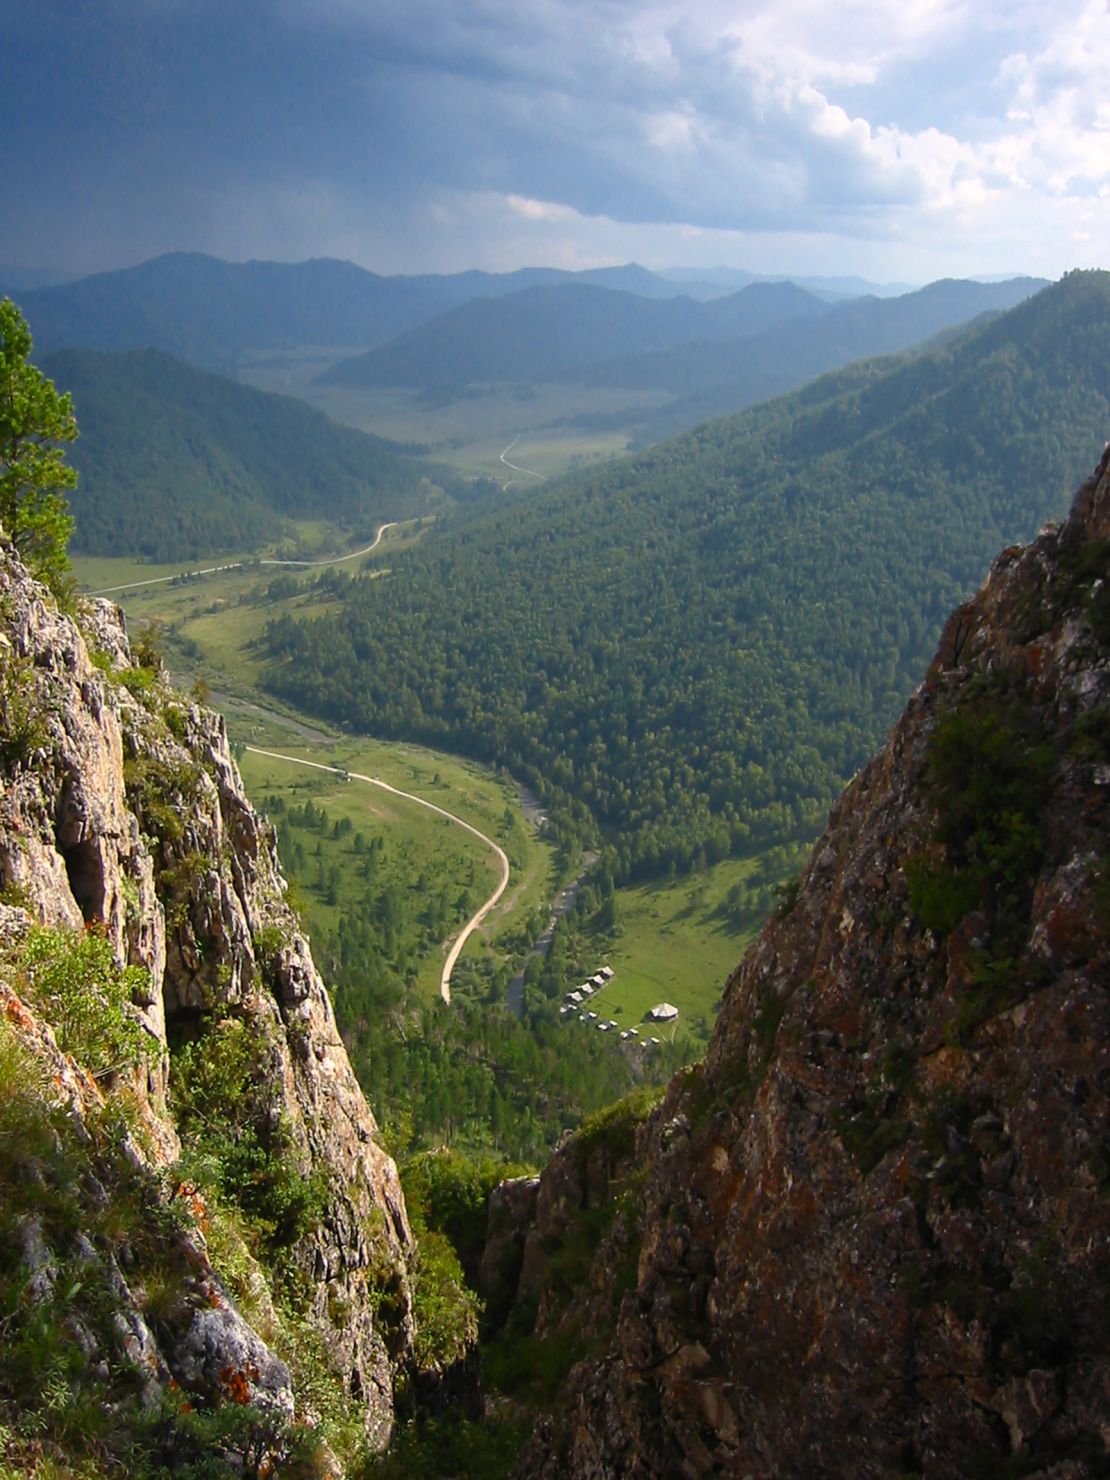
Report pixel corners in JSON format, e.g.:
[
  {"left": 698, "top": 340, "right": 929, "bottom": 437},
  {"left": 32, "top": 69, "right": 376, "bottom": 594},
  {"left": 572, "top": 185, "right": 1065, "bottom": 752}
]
[{"left": 0, "top": 545, "right": 413, "bottom": 1447}]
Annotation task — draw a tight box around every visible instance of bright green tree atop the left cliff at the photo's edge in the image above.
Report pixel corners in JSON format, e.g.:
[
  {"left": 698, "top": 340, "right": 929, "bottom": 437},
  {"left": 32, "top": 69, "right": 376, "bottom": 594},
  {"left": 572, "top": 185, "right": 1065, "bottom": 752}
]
[{"left": 0, "top": 297, "right": 77, "bottom": 591}]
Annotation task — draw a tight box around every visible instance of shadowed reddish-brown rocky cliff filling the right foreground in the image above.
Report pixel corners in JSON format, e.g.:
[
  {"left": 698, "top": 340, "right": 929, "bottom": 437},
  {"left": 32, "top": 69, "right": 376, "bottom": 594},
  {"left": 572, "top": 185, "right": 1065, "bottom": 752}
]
[{"left": 512, "top": 451, "right": 1110, "bottom": 1480}]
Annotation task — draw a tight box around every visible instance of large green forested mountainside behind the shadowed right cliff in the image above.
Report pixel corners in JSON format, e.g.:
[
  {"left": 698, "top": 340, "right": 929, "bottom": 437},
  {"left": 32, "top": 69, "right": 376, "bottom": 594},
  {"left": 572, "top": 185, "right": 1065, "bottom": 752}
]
[{"left": 269, "top": 272, "right": 1110, "bottom": 876}]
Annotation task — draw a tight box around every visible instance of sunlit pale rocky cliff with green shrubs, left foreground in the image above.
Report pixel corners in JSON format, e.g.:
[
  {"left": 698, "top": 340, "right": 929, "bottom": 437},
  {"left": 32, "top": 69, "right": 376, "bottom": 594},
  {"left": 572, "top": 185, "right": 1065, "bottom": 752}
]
[{"left": 0, "top": 545, "right": 413, "bottom": 1474}]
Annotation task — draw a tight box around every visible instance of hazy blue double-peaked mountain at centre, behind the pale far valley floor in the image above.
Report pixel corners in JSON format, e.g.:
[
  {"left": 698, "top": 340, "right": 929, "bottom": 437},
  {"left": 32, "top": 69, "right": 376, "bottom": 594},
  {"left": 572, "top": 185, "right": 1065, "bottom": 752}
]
[{"left": 317, "top": 283, "right": 829, "bottom": 389}]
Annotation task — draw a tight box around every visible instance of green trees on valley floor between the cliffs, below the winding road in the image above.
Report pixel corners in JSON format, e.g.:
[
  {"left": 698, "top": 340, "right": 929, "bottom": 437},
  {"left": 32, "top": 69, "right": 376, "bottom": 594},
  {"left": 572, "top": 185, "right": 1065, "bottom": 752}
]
[{"left": 260, "top": 793, "right": 688, "bottom": 1162}]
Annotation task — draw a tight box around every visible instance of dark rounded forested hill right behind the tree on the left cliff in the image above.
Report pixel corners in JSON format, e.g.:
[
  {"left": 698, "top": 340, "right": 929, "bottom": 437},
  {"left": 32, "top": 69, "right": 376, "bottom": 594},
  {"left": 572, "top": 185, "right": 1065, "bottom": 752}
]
[{"left": 41, "top": 349, "right": 460, "bottom": 561}]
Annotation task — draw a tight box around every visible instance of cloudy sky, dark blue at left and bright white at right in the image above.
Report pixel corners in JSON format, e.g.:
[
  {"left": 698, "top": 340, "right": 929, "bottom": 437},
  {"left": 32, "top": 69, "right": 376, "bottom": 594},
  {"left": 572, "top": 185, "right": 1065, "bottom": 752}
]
[{"left": 0, "top": 0, "right": 1110, "bottom": 283}]
